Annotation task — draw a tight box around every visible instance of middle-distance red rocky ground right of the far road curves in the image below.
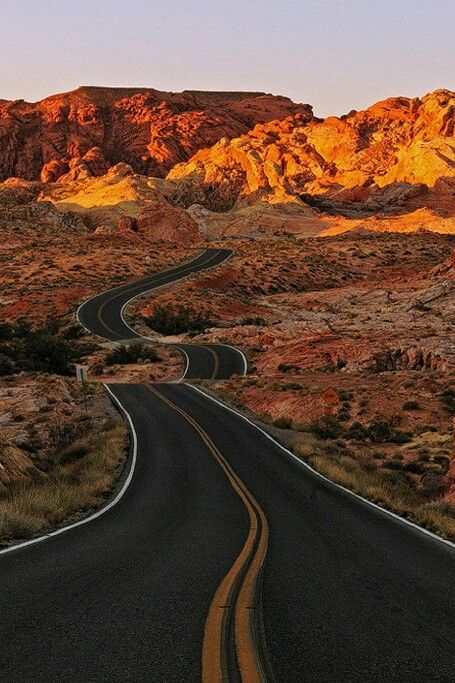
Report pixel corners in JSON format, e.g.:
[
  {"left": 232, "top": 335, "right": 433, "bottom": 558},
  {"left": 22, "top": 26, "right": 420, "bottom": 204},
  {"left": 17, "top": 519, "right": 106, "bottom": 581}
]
[{"left": 127, "top": 231, "right": 455, "bottom": 376}]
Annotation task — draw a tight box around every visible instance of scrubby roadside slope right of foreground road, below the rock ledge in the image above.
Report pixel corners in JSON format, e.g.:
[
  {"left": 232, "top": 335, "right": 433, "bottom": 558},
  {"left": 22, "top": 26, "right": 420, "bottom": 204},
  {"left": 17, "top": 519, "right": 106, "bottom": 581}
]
[{"left": 214, "top": 370, "right": 455, "bottom": 540}]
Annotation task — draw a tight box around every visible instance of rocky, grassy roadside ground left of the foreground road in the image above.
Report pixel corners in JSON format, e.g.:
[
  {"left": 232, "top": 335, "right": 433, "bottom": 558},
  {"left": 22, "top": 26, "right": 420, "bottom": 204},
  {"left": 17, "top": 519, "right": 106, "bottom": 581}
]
[{"left": 0, "top": 375, "right": 128, "bottom": 545}]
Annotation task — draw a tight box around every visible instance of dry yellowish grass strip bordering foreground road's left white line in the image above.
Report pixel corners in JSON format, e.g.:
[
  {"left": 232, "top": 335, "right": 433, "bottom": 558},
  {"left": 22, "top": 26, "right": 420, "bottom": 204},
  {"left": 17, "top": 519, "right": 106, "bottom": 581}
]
[{"left": 0, "top": 419, "right": 128, "bottom": 542}]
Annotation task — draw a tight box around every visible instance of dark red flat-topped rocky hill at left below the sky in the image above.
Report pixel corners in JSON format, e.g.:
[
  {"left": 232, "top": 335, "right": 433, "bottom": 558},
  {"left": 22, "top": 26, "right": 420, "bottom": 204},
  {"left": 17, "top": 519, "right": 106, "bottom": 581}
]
[{"left": 0, "top": 87, "right": 312, "bottom": 182}]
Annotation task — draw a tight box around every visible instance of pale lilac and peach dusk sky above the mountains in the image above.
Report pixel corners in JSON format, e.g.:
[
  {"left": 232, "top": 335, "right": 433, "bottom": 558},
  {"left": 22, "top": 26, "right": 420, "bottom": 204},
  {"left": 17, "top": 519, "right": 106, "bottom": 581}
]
[{"left": 0, "top": 0, "right": 455, "bottom": 116}]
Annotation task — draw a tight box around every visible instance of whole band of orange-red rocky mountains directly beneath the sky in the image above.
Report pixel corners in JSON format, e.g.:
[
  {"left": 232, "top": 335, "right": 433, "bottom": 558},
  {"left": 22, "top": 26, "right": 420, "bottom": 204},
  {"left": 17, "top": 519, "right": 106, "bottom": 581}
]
[{"left": 0, "top": 88, "right": 455, "bottom": 245}]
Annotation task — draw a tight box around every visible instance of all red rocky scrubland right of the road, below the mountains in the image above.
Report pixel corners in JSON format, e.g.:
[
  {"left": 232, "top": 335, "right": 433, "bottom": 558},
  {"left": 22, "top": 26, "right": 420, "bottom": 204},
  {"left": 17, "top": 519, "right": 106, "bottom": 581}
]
[{"left": 124, "top": 231, "right": 455, "bottom": 538}]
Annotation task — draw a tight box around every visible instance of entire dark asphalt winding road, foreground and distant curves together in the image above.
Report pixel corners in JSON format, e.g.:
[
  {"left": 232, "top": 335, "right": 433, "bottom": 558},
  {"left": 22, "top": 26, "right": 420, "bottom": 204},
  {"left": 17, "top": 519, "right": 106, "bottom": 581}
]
[{"left": 0, "top": 249, "right": 455, "bottom": 683}]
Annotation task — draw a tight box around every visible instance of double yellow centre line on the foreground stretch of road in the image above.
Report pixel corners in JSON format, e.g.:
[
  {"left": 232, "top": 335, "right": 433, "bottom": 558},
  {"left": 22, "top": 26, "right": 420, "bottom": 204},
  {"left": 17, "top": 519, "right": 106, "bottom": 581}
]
[{"left": 149, "top": 387, "right": 269, "bottom": 683}]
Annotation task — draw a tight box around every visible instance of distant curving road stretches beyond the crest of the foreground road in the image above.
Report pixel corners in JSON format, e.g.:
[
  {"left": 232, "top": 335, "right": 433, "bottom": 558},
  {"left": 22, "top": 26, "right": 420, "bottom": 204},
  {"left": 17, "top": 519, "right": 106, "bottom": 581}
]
[{"left": 77, "top": 249, "right": 247, "bottom": 379}]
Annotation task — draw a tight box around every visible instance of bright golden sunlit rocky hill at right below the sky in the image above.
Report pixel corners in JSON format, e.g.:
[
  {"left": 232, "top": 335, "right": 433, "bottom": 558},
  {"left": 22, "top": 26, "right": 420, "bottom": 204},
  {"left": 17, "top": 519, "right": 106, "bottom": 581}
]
[{"left": 168, "top": 90, "right": 455, "bottom": 211}]
